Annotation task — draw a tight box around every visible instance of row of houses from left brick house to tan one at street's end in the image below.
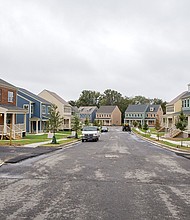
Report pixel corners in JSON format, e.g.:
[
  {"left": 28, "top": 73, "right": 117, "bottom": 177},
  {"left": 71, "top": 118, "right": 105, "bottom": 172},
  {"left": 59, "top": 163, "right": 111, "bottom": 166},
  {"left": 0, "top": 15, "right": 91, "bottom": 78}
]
[{"left": 0, "top": 79, "right": 121, "bottom": 139}]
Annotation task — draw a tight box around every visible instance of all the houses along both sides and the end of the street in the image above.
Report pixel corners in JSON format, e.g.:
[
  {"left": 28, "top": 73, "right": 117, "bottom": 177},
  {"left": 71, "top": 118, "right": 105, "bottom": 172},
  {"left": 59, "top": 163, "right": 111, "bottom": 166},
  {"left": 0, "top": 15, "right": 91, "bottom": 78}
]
[{"left": 0, "top": 79, "right": 190, "bottom": 138}]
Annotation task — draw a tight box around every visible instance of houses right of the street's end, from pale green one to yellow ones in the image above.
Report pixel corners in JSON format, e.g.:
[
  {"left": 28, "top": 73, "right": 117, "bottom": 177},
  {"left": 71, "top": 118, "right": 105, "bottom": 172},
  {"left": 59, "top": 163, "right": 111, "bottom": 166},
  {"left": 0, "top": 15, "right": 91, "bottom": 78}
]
[{"left": 124, "top": 84, "right": 190, "bottom": 138}]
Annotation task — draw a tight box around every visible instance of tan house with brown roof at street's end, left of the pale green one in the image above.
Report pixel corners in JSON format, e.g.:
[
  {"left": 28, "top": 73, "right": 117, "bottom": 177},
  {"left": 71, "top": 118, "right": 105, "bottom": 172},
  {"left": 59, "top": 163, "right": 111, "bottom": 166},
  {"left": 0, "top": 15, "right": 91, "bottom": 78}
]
[{"left": 96, "top": 106, "right": 121, "bottom": 126}]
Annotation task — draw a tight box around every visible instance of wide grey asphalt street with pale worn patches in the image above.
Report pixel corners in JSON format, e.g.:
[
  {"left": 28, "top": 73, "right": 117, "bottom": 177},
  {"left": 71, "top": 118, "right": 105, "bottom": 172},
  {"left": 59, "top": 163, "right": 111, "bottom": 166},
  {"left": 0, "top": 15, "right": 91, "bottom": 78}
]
[{"left": 0, "top": 128, "right": 190, "bottom": 220}]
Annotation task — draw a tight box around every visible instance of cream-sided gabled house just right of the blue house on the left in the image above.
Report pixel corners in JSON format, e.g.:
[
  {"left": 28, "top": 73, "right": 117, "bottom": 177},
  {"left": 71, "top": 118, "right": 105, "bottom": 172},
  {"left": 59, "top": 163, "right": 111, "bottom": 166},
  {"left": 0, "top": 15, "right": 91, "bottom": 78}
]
[{"left": 38, "top": 89, "right": 72, "bottom": 130}]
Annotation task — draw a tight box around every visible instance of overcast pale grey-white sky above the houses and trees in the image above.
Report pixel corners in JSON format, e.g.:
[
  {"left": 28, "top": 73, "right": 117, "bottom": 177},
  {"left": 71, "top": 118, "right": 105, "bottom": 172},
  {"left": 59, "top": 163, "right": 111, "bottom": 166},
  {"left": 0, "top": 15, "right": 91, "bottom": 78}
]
[{"left": 0, "top": 0, "right": 190, "bottom": 101}]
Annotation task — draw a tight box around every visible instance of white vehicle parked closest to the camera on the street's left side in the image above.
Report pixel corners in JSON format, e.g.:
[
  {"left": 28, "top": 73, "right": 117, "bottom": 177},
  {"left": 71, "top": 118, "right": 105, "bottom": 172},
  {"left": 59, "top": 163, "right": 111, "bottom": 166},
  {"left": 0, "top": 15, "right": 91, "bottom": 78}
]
[{"left": 82, "top": 126, "right": 100, "bottom": 142}]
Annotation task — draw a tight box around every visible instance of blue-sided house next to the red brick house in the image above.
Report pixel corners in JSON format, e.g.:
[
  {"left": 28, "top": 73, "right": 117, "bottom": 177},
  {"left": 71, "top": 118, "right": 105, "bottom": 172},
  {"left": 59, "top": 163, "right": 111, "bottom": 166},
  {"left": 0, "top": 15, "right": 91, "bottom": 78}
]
[{"left": 17, "top": 88, "right": 51, "bottom": 133}]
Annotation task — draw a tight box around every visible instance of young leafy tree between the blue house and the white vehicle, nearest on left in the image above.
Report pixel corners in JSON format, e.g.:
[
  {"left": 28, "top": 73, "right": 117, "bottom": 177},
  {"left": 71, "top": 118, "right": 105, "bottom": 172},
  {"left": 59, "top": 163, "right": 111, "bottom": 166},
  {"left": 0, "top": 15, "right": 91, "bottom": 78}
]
[{"left": 48, "top": 104, "right": 64, "bottom": 144}]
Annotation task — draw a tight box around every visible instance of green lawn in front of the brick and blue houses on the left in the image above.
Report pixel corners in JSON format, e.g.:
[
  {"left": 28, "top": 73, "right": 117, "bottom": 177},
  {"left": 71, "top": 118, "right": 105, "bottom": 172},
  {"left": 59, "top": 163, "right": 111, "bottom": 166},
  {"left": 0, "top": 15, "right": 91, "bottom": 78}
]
[{"left": 0, "top": 131, "right": 71, "bottom": 146}]
